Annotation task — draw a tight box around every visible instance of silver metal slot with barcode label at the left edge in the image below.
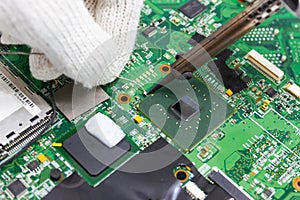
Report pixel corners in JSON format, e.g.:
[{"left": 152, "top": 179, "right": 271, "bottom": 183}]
[{"left": 0, "top": 62, "right": 52, "bottom": 165}]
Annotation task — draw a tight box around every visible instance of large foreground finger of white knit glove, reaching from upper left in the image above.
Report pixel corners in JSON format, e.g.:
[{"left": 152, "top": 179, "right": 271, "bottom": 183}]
[{"left": 0, "top": 0, "right": 123, "bottom": 87}]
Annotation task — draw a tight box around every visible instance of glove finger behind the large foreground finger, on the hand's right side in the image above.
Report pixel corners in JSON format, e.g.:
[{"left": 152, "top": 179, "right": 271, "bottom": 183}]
[{"left": 95, "top": 0, "right": 143, "bottom": 79}]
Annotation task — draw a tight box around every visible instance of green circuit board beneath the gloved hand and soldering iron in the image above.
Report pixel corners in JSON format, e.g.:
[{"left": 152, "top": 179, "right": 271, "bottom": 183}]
[{"left": 0, "top": 0, "right": 300, "bottom": 200}]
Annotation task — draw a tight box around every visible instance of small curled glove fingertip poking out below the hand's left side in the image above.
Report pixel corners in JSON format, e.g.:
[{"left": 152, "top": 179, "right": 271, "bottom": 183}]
[{"left": 29, "top": 49, "right": 62, "bottom": 81}]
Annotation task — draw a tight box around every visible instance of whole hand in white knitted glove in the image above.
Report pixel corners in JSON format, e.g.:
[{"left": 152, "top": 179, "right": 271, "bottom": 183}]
[{"left": 0, "top": 0, "right": 143, "bottom": 87}]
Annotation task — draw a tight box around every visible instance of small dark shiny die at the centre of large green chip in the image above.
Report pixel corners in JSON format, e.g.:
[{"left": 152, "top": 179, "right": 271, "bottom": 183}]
[{"left": 171, "top": 96, "right": 200, "bottom": 120}]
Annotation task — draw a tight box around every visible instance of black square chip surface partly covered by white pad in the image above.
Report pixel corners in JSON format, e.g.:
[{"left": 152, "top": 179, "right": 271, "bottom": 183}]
[{"left": 63, "top": 128, "right": 131, "bottom": 176}]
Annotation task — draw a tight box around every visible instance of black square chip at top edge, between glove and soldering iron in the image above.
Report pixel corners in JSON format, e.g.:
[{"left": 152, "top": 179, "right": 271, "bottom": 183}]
[{"left": 179, "top": 0, "right": 206, "bottom": 19}]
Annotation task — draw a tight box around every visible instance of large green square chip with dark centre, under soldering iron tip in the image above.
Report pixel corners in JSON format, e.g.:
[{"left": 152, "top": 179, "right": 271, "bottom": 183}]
[{"left": 139, "top": 78, "right": 234, "bottom": 151}]
